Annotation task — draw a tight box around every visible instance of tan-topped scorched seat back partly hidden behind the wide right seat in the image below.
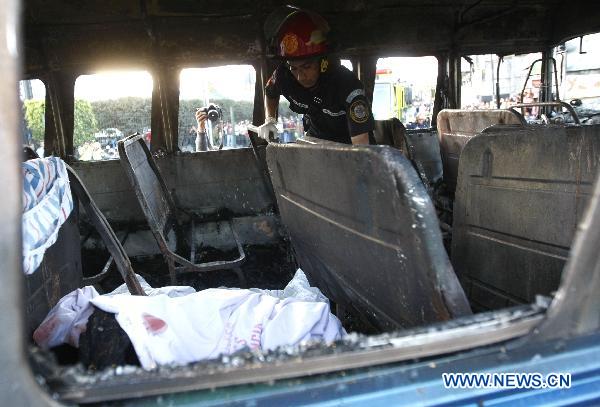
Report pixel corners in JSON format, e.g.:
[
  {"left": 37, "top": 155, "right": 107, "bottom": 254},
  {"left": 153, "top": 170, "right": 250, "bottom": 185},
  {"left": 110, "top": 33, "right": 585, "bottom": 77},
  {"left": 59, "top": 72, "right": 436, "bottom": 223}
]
[{"left": 437, "top": 109, "right": 526, "bottom": 196}]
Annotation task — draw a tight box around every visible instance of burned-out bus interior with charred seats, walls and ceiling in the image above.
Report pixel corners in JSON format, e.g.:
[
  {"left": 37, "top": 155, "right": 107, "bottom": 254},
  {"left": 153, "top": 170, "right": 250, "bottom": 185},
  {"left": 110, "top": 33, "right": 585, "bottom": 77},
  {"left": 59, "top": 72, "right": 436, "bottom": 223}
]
[{"left": 5, "top": 0, "right": 600, "bottom": 403}]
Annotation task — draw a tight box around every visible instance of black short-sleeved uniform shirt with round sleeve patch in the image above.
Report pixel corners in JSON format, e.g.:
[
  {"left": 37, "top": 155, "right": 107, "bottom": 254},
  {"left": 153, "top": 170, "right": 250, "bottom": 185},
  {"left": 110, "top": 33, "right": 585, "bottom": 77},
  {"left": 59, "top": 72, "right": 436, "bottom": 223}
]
[{"left": 265, "top": 64, "right": 374, "bottom": 144}]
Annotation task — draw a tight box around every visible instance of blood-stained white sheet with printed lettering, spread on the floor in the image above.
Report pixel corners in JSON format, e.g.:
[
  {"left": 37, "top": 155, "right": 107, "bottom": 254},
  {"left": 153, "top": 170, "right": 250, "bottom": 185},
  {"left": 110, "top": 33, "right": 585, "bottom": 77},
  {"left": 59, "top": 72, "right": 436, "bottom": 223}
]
[{"left": 35, "top": 269, "right": 346, "bottom": 369}]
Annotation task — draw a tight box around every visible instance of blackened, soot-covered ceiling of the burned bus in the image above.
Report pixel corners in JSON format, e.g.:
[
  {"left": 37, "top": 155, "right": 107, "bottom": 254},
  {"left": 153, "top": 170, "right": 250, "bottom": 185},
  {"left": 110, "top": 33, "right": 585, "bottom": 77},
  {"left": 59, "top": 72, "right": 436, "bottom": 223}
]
[{"left": 22, "top": 0, "right": 600, "bottom": 73}]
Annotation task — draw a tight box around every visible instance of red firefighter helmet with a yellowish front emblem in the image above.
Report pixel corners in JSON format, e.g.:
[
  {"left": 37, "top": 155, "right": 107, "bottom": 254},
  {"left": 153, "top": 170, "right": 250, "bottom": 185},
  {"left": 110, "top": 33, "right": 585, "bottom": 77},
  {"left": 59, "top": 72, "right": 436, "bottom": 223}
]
[{"left": 277, "top": 10, "right": 329, "bottom": 59}]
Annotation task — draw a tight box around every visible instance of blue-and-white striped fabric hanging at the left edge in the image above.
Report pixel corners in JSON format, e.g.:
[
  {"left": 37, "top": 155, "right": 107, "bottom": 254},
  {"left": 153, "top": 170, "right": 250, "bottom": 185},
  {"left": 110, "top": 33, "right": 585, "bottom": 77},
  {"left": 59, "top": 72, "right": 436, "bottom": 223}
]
[{"left": 22, "top": 157, "right": 73, "bottom": 274}]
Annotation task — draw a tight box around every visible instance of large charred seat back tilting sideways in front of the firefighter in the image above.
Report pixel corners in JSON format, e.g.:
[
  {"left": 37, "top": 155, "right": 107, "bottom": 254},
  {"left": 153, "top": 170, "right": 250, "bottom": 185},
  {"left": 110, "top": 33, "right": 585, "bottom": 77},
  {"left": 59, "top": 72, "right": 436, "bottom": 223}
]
[{"left": 267, "top": 143, "right": 470, "bottom": 331}]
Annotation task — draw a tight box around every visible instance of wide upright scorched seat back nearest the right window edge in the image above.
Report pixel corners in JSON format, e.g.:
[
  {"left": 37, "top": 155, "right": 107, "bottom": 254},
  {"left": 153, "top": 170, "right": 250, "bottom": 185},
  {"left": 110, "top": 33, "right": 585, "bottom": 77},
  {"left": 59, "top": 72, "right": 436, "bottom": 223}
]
[{"left": 452, "top": 125, "right": 600, "bottom": 310}]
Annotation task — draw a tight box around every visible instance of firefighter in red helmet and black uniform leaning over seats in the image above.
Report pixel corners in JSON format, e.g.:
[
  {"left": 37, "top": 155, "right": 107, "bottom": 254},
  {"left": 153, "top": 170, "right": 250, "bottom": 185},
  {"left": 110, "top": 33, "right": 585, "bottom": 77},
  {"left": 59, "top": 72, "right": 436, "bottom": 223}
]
[{"left": 259, "top": 10, "right": 374, "bottom": 144}]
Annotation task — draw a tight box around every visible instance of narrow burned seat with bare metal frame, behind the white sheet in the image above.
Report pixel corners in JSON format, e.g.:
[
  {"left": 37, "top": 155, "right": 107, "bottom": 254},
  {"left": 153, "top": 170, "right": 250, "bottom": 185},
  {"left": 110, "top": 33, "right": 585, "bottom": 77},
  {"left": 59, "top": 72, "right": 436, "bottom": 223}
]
[{"left": 119, "top": 134, "right": 246, "bottom": 285}]
